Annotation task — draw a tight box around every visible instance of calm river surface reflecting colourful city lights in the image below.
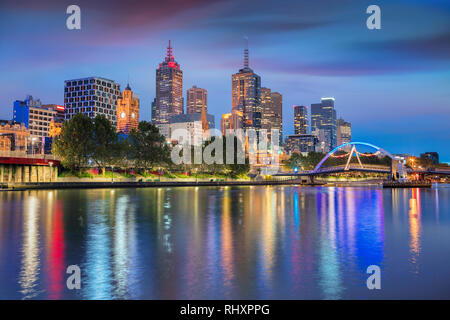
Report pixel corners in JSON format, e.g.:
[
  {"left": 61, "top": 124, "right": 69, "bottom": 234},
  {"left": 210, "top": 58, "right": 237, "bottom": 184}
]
[{"left": 0, "top": 185, "right": 450, "bottom": 299}]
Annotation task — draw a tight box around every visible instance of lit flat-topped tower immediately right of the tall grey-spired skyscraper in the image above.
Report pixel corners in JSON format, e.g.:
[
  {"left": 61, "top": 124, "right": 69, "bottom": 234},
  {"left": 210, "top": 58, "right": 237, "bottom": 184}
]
[{"left": 261, "top": 88, "right": 283, "bottom": 144}]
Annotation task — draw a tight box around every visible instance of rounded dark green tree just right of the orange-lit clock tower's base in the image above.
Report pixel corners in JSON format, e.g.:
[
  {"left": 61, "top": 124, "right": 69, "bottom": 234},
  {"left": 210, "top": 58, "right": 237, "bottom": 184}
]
[{"left": 128, "top": 121, "right": 170, "bottom": 170}]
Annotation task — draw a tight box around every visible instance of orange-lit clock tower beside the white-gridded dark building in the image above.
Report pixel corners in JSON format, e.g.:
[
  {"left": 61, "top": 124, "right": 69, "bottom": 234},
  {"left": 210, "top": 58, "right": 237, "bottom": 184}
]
[{"left": 117, "top": 84, "right": 139, "bottom": 134}]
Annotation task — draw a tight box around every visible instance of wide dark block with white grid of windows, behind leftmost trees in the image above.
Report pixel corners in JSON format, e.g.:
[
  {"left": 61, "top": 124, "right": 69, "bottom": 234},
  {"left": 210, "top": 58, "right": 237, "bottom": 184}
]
[{"left": 64, "top": 77, "right": 120, "bottom": 127}]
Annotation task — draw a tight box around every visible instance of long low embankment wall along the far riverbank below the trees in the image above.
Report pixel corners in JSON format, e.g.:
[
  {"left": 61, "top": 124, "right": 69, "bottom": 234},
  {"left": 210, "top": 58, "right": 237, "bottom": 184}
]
[{"left": 0, "top": 179, "right": 323, "bottom": 191}]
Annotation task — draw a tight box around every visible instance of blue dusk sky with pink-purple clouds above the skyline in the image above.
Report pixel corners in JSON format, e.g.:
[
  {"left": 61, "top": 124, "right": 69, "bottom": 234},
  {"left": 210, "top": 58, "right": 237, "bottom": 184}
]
[{"left": 0, "top": 0, "right": 450, "bottom": 162}]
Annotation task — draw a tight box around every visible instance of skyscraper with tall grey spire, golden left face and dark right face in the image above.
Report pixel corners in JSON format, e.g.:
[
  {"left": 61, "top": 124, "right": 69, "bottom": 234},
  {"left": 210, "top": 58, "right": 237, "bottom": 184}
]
[{"left": 231, "top": 43, "right": 262, "bottom": 129}]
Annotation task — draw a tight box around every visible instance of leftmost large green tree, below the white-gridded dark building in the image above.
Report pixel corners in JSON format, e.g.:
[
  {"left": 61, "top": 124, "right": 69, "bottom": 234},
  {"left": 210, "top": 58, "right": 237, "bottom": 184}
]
[{"left": 52, "top": 113, "right": 94, "bottom": 170}]
